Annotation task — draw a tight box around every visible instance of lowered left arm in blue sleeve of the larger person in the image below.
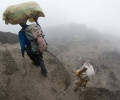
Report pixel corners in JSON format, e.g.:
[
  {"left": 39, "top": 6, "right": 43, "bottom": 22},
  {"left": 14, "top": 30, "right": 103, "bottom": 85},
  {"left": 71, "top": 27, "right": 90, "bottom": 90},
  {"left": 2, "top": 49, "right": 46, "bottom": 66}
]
[{"left": 18, "top": 31, "right": 25, "bottom": 57}]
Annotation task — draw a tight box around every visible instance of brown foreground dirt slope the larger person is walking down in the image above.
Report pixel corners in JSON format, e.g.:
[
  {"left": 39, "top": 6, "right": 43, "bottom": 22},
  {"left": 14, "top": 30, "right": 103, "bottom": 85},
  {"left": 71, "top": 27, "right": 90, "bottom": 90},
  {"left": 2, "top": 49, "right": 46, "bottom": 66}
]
[{"left": 0, "top": 44, "right": 71, "bottom": 100}]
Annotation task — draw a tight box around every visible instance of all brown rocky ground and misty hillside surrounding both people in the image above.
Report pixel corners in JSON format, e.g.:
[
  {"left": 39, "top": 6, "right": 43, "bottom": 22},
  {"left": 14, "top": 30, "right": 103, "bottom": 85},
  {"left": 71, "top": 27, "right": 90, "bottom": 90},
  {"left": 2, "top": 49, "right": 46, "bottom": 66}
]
[{"left": 0, "top": 23, "right": 120, "bottom": 100}]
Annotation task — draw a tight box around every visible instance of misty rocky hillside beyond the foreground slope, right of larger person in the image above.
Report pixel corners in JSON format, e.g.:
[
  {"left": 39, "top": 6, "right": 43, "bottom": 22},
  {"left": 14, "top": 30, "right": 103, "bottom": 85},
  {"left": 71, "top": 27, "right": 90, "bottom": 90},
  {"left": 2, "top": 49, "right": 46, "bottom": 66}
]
[{"left": 46, "top": 23, "right": 120, "bottom": 90}]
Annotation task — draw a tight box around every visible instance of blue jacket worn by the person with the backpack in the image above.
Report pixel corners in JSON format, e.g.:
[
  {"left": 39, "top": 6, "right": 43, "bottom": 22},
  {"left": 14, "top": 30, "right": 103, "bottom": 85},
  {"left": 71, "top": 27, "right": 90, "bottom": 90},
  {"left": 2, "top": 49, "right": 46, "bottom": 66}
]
[{"left": 18, "top": 24, "right": 45, "bottom": 55}]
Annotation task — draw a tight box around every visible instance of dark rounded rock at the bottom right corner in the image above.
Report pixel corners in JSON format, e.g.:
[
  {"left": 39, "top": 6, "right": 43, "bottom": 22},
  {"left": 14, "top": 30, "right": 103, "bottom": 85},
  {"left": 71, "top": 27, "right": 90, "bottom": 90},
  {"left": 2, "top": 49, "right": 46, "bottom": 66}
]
[{"left": 79, "top": 88, "right": 119, "bottom": 100}]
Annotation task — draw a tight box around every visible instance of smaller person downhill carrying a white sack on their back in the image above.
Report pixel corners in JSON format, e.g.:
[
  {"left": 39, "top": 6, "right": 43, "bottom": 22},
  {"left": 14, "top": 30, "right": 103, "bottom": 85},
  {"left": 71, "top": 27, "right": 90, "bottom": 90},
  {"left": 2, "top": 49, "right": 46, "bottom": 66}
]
[{"left": 74, "top": 62, "right": 95, "bottom": 92}]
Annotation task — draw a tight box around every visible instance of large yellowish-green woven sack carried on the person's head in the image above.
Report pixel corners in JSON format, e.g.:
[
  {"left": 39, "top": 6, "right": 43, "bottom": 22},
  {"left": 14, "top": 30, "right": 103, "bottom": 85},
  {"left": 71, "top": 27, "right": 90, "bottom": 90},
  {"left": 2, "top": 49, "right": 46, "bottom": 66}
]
[{"left": 3, "top": 1, "right": 45, "bottom": 24}]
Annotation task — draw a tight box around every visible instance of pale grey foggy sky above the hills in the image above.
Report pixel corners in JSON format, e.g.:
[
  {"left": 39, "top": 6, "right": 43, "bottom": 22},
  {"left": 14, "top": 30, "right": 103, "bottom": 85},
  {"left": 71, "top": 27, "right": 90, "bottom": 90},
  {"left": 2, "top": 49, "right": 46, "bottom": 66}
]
[{"left": 0, "top": 0, "right": 120, "bottom": 34}]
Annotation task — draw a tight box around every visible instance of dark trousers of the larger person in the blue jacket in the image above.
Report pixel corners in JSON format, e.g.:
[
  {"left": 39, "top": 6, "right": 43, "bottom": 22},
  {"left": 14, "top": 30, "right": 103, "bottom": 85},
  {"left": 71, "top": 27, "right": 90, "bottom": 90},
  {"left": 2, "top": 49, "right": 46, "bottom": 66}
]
[{"left": 27, "top": 53, "right": 47, "bottom": 74}]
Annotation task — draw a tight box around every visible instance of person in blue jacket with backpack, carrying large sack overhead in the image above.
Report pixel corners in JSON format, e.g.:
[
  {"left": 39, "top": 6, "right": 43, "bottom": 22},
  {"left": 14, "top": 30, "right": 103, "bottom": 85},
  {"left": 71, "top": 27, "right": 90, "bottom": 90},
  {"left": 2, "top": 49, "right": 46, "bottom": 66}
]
[{"left": 3, "top": 1, "right": 47, "bottom": 77}]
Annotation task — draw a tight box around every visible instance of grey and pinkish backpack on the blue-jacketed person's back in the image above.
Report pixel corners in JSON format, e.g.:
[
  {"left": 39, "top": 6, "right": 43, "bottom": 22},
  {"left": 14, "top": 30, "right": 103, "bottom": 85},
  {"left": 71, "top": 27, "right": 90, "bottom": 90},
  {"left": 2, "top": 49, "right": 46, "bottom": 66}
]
[{"left": 24, "top": 24, "right": 47, "bottom": 54}]
